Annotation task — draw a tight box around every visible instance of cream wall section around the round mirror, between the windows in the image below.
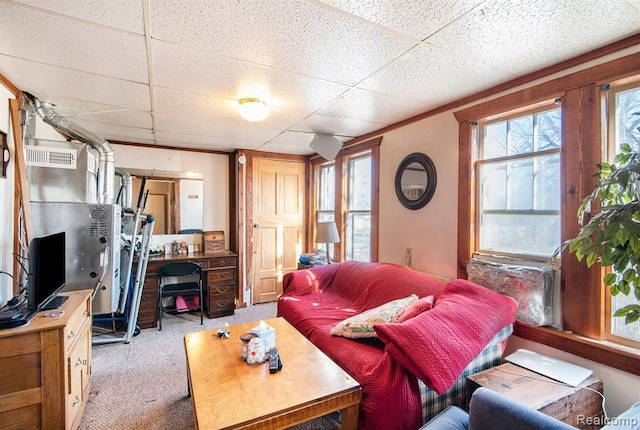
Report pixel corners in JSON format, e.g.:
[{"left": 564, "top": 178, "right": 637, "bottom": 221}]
[{"left": 378, "top": 112, "right": 458, "bottom": 278}]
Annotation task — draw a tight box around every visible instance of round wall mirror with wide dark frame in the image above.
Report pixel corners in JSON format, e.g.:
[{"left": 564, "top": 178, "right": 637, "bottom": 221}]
[{"left": 396, "top": 152, "right": 436, "bottom": 210}]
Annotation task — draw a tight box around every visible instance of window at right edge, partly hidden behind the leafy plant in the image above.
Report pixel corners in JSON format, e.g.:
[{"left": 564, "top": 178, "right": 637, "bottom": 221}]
[{"left": 607, "top": 82, "right": 640, "bottom": 346}]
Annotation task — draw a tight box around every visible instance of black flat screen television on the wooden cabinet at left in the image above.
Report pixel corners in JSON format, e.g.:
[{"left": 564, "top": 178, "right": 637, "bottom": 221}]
[{"left": 27, "top": 232, "right": 67, "bottom": 311}]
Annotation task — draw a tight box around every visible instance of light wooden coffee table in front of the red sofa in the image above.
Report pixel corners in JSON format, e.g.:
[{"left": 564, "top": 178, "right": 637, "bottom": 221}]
[{"left": 184, "top": 318, "right": 362, "bottom": 430}]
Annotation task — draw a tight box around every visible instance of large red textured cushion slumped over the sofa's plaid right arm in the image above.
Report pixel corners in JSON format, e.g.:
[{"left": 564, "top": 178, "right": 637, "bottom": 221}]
[{"left": 374, "top": 279, "right": 518, "bottom": 394}]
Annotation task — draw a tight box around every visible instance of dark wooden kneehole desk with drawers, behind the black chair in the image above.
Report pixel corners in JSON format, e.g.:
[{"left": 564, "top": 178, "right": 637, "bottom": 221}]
[{"left": 138, "top": 251, "right": 238, "bottom": 328}]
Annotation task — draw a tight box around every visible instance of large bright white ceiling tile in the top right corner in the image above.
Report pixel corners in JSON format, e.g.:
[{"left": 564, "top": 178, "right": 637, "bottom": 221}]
[{"left": 427, "top": 0, "right": 640, "bottom": 75}]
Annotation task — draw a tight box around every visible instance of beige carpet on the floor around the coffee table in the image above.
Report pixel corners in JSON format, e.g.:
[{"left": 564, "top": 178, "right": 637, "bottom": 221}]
[{"left": 80, "top": 302, "right": 337, "bottom": 430}]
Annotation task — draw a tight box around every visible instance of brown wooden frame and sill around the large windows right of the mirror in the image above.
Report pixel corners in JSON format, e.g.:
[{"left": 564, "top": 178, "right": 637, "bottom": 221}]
[{"left": 454, "top": 53, "right": 640, "bottom": 375}]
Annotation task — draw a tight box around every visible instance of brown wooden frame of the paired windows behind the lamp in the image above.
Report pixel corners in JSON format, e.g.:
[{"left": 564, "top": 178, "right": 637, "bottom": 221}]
[{"left": 307, "top": 136, "right": 382, "bottom": 262}]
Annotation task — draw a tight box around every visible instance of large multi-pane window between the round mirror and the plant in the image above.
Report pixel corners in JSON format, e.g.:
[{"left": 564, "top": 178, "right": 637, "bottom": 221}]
[{"left": 477, "top": 107, "right": 561, "bottom": 257}]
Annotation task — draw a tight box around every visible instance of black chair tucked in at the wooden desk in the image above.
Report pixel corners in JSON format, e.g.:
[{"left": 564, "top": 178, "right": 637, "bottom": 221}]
[{"left": 158, "top": 261, "right": 204, "bottom": 330}]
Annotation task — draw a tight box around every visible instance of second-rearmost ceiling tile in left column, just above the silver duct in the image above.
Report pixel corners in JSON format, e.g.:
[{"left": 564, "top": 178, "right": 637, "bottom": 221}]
[{"left": 48, "top": 97, "right": 153, "bottom": 129}]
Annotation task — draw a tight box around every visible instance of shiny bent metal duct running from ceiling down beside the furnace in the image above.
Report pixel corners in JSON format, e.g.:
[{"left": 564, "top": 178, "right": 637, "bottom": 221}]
[{"left": 28, "top": 94, "right": 115, "bottom": 204}]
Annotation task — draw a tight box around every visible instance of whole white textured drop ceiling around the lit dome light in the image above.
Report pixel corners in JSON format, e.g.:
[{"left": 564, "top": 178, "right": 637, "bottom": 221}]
[{"left": 0, "top": 0, "right": 640, "bottom": 154}]
